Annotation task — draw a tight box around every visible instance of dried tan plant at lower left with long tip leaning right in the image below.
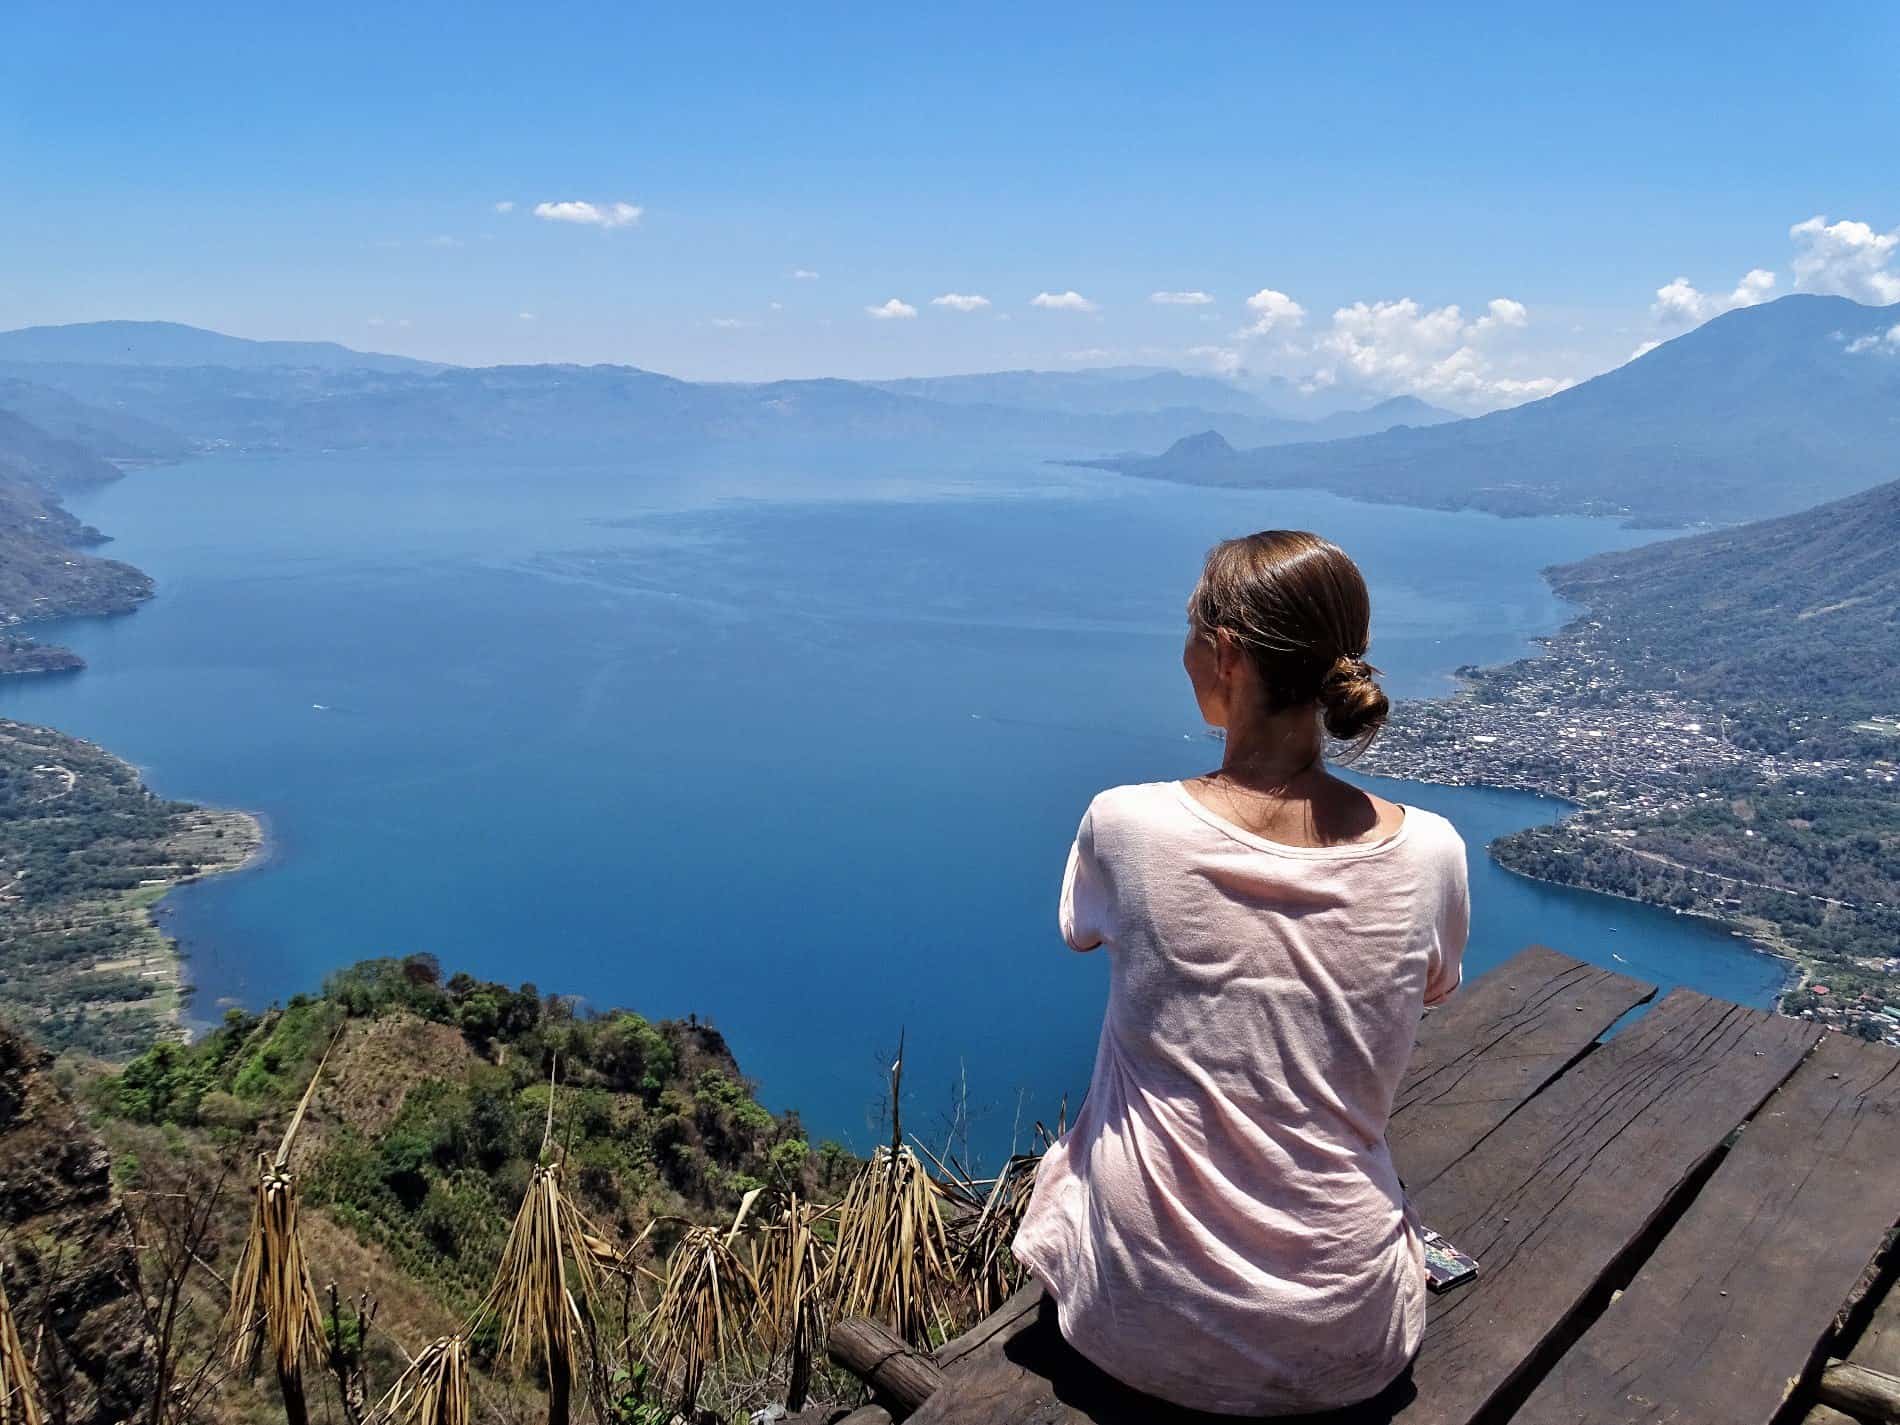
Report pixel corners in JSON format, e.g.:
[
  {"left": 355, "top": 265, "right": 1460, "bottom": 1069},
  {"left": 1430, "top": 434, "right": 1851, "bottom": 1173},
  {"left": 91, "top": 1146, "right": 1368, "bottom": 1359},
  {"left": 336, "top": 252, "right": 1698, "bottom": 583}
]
[{"left": 226, "top": 1039, "right": 336, "bottom": 1425}]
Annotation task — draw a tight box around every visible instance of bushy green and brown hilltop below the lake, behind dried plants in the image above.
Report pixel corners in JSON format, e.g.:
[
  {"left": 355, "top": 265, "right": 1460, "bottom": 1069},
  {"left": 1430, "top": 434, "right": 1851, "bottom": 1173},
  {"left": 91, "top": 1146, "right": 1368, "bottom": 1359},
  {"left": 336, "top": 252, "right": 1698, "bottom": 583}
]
[{"left": 93, "top": 956, "right": 821, "bottom": 1309}]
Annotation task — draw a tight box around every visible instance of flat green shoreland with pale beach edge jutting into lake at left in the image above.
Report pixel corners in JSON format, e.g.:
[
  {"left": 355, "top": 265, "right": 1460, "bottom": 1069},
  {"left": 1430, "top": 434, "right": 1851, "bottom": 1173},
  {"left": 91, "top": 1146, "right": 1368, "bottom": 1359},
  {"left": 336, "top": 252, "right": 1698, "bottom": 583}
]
[{"left": 0, "top": 720, "right": 258, "bottom": 1055}]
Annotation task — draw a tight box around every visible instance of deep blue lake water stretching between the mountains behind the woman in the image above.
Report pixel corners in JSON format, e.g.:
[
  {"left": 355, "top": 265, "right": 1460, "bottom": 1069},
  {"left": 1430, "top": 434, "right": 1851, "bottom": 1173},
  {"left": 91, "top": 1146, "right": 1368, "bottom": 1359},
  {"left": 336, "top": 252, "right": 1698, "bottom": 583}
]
[{"left": 0, "top": 450, "right": 1780, "bottom": 1157}]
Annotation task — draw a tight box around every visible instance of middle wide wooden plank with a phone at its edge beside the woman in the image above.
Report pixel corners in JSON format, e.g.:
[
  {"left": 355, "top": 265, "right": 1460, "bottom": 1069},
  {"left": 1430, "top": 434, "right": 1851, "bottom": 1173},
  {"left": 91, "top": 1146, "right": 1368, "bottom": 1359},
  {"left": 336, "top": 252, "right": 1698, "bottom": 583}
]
[{"left": 1406, "top": 990, "right": 1820, "bottom": 1425}]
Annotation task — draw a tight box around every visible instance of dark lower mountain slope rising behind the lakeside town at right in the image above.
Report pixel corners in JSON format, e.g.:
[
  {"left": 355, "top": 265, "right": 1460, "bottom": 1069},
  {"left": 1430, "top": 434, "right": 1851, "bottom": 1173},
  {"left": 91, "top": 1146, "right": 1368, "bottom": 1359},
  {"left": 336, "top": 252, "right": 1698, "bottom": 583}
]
[{"left": 1549, "top": 481, "right": 1900, "bottom": 716}]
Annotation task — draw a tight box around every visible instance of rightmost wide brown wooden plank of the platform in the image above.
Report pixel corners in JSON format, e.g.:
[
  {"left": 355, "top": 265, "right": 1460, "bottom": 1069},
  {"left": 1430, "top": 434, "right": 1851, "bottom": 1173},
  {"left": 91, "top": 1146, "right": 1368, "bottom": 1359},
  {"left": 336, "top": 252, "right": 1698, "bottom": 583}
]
[{"left": 1512, "top": 1034, "right": 1900, "bottom": 1425}]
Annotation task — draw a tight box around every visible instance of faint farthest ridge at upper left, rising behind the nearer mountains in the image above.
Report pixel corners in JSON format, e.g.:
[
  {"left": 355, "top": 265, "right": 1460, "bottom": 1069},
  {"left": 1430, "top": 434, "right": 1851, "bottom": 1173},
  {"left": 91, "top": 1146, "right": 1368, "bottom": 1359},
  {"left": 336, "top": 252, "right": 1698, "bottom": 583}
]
[{"left": 0, "top": 321, "right": 441, "bottom": 371}]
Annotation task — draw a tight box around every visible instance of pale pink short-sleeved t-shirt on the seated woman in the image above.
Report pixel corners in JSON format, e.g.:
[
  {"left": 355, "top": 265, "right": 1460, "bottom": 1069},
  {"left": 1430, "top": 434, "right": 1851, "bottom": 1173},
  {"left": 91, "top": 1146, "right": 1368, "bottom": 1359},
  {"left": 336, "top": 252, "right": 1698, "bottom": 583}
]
[{"left": 1015, "top": 783, "right": 1469, "bottom": 1416}]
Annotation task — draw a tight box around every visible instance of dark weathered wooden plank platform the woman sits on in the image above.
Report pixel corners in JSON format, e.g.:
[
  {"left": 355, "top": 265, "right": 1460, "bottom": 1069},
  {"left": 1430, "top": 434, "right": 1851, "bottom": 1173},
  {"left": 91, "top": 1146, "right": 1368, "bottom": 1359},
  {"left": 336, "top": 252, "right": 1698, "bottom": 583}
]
[{"left": 839, "top": 948, "right": 1900, "bottom": 1425}]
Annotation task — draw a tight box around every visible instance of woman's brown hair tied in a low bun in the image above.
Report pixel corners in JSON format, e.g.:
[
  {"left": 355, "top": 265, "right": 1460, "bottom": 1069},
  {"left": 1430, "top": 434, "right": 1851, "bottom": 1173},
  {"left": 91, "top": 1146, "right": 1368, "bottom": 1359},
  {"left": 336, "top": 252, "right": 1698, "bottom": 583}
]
[{"left": 1188, "top": 530, "right": 1391, "bottom": 745}]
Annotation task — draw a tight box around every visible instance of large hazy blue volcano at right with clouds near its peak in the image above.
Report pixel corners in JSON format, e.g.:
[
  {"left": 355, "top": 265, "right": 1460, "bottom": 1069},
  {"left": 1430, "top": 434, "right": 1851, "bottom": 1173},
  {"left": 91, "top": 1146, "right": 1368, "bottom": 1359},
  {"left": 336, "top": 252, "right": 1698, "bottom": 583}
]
[{"left": 1102, "top": 296, "right": 1900, "bottom": 523}]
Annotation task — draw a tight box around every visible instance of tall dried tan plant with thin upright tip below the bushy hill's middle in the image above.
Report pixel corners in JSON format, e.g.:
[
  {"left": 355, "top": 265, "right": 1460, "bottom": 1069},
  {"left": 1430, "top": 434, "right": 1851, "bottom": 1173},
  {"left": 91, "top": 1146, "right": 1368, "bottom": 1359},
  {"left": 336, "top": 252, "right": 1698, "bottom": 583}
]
[{"left": 485, "top": 1085, "right": 619, "bottom": 1425}]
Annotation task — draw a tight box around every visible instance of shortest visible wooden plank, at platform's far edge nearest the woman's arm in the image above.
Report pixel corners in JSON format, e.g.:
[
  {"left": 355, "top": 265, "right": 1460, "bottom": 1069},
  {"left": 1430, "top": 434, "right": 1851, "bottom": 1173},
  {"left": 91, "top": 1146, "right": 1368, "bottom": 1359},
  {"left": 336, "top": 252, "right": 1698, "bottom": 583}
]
[{"left": 1385, "top": 944, "right": 1657, "bottom": 1193}]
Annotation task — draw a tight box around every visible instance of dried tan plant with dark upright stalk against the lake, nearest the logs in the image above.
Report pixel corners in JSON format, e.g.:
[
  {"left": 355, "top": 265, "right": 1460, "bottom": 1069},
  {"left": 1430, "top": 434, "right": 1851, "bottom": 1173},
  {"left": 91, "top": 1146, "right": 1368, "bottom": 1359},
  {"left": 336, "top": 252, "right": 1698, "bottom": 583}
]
[{"left": 825, "top": 1047, "right": 956, "bottom": 1343}]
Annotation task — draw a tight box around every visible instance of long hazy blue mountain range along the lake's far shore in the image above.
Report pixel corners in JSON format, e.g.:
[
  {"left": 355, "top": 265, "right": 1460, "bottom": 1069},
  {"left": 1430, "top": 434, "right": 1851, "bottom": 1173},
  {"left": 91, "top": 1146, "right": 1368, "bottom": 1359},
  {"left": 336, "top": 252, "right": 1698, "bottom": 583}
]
[{"left": 0, "top": 321, "right": 1454, "bottom": 458}]
